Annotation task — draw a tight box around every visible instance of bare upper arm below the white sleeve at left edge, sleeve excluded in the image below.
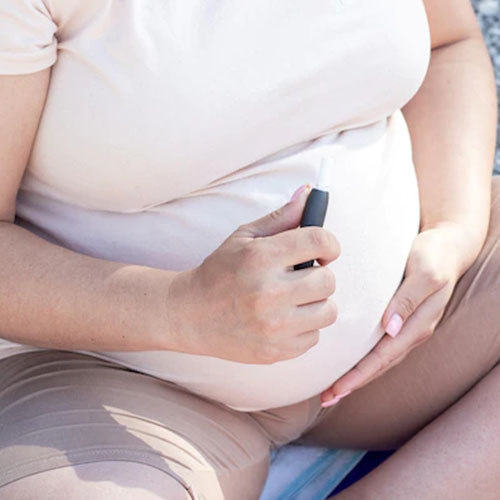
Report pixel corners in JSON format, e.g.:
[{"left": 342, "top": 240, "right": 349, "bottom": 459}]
[{"left": 0, "top": 68, "right": 50, "bottom": 222}]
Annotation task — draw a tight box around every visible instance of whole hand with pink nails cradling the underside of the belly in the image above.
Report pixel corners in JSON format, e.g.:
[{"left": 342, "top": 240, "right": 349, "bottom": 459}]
[{"left": 321, "top": 222, "right": 482, "bottom": 406}]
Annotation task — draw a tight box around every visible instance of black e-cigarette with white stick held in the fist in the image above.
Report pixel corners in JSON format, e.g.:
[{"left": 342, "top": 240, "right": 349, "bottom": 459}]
[{"left": 293, "top": 157, "right": 333, "bottom": 271}]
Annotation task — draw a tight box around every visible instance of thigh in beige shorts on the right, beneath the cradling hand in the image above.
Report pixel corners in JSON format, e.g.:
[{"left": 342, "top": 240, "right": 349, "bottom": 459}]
[{"left": 296, "top": 177, "right": 500, "bottom": 449}]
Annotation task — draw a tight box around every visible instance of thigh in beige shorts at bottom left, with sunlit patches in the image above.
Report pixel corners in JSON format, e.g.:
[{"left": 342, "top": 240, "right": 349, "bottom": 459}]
[{"left": 0, "top": 350, "right": 270, "bottom": 500}]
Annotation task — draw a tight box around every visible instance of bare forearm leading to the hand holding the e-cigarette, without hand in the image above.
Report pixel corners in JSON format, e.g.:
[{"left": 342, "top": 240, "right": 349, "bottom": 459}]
[{"left": 0, "top": 222, "right": 182, "bottom": 351}]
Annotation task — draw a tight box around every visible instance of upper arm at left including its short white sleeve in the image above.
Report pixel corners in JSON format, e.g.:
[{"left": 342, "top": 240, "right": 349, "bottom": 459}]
[{"left": 0, "top": 0, "right": 57, "bottom": 221}]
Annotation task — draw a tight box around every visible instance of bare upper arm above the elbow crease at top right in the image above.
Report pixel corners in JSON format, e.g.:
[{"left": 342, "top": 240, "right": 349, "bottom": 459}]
[{"left": 423, "top": 0, "right": 482, "bottom": 49}]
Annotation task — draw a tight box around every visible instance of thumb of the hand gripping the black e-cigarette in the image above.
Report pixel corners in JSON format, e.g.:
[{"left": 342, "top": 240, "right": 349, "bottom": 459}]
[{"left": 238, "top": 184, "right": 311, "bottom": 238}]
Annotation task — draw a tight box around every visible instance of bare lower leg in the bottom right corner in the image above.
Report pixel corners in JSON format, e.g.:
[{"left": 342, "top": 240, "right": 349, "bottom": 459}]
[{"left": 335, "top": 366, "right": 500, "bottom": 500}]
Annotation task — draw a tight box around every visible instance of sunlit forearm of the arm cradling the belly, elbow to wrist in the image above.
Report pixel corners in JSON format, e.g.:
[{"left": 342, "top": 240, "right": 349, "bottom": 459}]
[{"left": 403, "top": 36, "right": 497, "bottom": 258}]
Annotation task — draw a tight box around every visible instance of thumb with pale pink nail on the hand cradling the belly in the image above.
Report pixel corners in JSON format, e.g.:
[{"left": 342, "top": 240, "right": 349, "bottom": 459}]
[{"left": 382, "top": 274, "right": 432, "bottom": 337}]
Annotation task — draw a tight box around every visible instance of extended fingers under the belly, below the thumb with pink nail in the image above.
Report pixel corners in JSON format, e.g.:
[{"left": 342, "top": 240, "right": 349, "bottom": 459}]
[{"left": 321, "top": 290, "right": 450, "bottom": 402}]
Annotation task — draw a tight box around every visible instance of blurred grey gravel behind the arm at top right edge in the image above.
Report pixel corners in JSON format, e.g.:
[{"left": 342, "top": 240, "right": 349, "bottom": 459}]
[{"left": 472, "top": 0, "right": 500, "bottom": 174}]
